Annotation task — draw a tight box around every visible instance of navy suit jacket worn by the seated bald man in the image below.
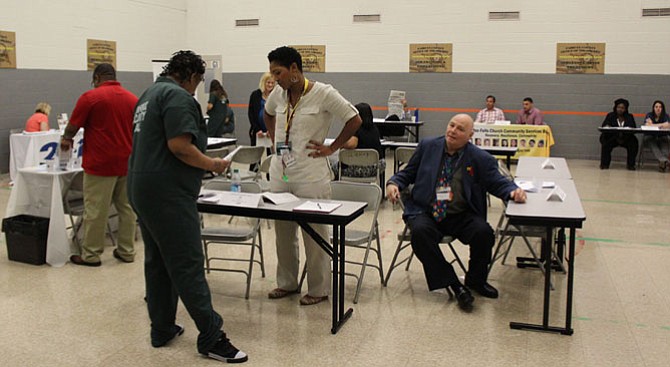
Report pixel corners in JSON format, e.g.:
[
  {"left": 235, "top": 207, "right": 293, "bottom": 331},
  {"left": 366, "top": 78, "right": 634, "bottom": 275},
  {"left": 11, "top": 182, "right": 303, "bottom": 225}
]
[{"left": 388, "top": 136, "right": 517, "bottom": 219}]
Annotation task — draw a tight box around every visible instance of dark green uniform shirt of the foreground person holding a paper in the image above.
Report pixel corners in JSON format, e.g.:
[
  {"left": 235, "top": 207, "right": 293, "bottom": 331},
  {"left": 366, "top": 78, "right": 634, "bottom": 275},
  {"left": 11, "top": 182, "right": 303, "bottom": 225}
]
[{"left": 128, "top": 77, "right": 207, "bottom": 196}]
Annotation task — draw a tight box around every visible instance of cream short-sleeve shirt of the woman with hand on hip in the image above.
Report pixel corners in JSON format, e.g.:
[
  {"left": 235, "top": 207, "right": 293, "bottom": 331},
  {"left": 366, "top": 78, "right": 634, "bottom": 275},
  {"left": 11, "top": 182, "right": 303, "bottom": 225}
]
[{"left": 265, "top": 82, "right": 358, "bottom": 183}]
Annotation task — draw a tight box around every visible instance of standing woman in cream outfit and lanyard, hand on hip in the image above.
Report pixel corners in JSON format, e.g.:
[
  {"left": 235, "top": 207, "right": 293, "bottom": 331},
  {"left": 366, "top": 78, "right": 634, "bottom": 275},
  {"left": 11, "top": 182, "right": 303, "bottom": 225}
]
[{"left": 264, "top": 46, "right": 361, "bottom": 305}]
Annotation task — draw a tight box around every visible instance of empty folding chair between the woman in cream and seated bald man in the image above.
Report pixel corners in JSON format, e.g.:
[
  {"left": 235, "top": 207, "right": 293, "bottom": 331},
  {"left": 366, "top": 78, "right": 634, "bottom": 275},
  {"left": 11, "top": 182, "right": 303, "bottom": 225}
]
[{"left": 298, "top": 181, "right": 384, "bottom": 303}]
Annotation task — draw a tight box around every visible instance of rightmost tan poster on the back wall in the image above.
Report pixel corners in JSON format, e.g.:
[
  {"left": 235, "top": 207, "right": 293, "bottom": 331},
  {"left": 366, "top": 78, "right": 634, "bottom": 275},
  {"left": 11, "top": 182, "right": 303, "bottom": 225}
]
[{"left": 556, "top": 43, "right": 605, "bottom": 74}]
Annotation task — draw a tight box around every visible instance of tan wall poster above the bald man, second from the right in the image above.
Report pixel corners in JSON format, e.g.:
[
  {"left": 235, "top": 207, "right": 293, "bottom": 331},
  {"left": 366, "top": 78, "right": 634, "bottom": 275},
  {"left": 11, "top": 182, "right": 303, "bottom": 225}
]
[{"left": 409, "top": 43, "right": 453, "bottom": 73}]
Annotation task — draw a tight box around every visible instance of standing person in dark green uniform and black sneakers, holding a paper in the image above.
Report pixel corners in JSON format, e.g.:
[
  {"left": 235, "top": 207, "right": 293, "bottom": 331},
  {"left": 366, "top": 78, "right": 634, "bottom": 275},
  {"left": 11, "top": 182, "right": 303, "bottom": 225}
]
[{"left": 128, "top": 51, "right": 248, "bottom": 363}]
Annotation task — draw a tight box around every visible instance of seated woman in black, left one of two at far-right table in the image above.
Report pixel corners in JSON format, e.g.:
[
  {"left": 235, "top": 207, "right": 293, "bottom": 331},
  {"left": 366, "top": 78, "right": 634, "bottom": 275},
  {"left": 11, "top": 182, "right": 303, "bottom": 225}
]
[{"left": 600, "top": 98, "right": 638, "bottom": 171}]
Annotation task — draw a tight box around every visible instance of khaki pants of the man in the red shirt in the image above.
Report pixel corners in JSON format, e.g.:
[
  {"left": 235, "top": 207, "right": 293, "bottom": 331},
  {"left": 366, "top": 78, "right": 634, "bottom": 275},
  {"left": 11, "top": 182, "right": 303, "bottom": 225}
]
[{"left": 81, "top": 173, "right": 136, "bottom": 262}]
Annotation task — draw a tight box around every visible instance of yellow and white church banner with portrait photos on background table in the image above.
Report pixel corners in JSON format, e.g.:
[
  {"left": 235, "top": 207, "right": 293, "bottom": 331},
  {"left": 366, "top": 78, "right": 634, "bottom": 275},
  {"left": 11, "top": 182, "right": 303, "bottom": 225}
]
[{"left": 471, "top": 124, "right": 554, "bottom": 159}]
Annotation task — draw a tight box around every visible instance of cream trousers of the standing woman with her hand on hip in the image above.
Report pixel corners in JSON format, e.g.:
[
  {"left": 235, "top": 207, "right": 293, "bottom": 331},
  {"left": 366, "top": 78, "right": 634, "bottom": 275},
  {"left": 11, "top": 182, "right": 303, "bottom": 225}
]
[{"left": 270, "top": 180, "right": 331, "bottom": 297}]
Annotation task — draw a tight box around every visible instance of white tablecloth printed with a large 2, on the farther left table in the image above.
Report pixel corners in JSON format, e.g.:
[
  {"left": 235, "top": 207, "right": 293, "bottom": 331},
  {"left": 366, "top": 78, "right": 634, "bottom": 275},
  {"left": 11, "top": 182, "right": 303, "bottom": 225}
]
[{"left": 9, "top": 129, "right": 84, "bottom": 181}]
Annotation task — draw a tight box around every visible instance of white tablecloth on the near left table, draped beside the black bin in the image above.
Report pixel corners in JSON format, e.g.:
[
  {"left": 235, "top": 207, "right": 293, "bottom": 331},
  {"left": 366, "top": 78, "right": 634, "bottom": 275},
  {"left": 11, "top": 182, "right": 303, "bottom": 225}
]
[{"left": 5, "top": 166, "right": 81, "bottom": 266}]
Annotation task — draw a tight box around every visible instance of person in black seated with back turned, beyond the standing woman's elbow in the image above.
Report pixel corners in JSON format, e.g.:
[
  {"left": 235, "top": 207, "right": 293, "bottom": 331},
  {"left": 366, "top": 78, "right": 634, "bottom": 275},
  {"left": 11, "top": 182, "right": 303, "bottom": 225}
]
[{"left": 333, "top": 103, "right": 386, "bottom": 177}]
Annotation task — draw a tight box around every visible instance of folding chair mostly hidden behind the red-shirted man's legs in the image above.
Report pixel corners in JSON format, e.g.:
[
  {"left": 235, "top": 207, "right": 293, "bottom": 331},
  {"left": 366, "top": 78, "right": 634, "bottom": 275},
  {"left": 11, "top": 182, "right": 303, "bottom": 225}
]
[{"left": 63, "top": 171, "right": 117, "bottom": 248}]
